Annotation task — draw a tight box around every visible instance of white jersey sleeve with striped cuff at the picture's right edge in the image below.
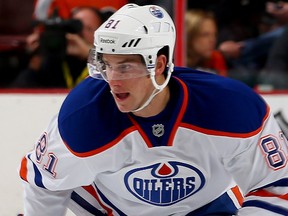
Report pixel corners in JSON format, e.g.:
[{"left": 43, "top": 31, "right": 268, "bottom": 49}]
[{"left": 224, "top": 112, "right": 288, "bottom": 216}]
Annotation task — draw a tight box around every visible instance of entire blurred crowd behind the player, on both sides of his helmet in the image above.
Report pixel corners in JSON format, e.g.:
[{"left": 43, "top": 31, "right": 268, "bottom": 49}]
[{"left": 0, "top": 0, "right": 288, "bottom": 90}]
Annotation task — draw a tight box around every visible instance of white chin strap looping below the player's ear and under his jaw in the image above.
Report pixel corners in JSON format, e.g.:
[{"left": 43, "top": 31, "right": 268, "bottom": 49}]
[{"left": 130, "top": 63, "right": 174, "bottom": 112}]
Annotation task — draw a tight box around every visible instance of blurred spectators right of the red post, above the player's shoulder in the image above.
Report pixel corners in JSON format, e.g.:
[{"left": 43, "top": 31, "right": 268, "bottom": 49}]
[{"left": 185, "top": 0, "right": 288, "bottom": 91}]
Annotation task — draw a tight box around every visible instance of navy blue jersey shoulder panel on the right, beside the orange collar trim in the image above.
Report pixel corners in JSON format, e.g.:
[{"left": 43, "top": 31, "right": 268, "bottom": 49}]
[{"left": 174, "top": 68, "right": 269, "bottom": 134}]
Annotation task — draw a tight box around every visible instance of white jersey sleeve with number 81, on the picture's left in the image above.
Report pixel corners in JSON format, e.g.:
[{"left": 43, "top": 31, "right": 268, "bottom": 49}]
[{"left": 19, "top": 116, "right": 94, "bottom": 215}]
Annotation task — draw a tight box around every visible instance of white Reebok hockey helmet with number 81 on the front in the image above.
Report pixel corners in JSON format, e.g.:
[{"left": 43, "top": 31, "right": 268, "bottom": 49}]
[{"left": 88, "top": 4, "right": 176, "bottom": 88}]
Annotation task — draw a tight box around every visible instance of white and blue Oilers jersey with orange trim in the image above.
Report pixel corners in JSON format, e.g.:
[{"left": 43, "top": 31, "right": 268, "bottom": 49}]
[{"left": 19, "top": 68, "right": 288, "bottom": 216}]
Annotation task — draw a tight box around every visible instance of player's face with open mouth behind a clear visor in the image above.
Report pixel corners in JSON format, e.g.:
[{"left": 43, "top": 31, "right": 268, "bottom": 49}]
[{"left": 103, "top": 54, "right": 154, "bottom": 112}]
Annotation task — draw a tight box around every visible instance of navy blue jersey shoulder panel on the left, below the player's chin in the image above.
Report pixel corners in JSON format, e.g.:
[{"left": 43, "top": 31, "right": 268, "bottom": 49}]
[{"left": 58, "top": 78, "right": 131, "bottom": 156}]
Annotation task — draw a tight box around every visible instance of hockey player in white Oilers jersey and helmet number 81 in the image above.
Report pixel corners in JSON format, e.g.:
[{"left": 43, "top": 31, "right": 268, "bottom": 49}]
[{"left": 19, "top": 4, "right": 288, "bottom": 216}]
